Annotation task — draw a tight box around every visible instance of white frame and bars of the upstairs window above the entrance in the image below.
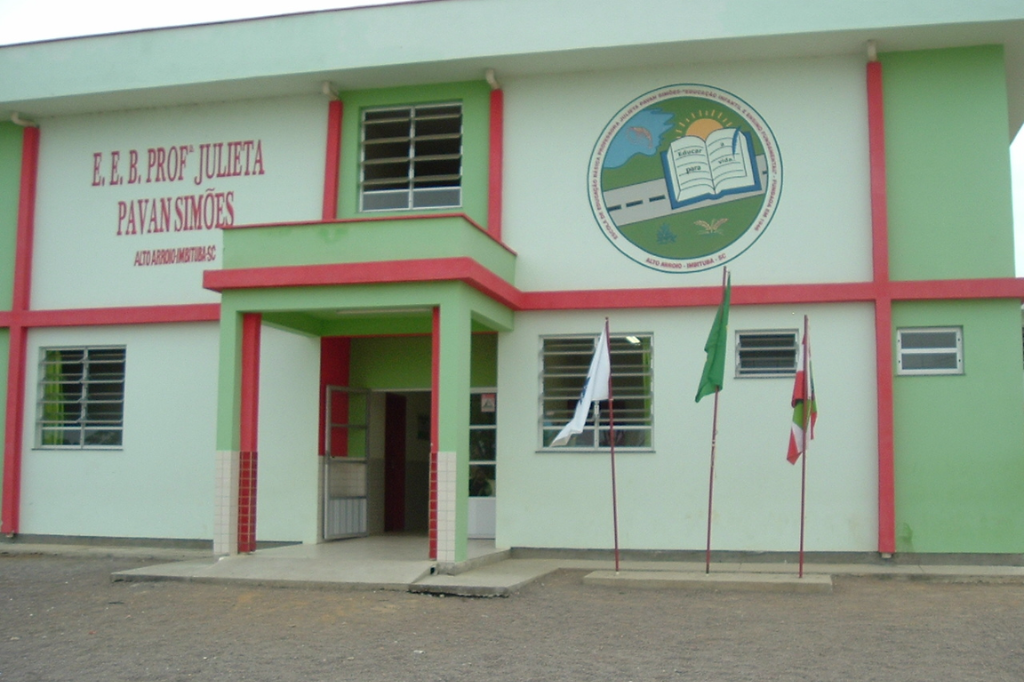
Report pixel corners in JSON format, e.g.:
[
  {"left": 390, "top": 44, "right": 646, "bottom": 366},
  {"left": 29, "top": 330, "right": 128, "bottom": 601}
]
[{"left": 359, "top": 101, "right": 465, "bottom": 213}]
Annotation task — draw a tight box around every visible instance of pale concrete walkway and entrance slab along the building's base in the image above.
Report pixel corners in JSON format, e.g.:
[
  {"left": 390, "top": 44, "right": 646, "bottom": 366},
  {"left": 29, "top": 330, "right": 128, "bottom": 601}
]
[{"left": 8, "top": 536, "right": 1024, "bottom": 596}]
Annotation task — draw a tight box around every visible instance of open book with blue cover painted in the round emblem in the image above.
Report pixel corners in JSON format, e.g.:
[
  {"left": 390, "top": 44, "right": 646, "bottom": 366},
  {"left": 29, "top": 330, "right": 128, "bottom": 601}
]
[{"left": 662, "top": 128, "right": 761, "bottom": 209}]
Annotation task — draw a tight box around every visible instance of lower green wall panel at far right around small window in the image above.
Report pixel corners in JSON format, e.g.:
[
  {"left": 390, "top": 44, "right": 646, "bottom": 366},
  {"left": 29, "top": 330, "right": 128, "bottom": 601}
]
[{"left": 893, "top": 300, "right": 1024, "bottom": 553}]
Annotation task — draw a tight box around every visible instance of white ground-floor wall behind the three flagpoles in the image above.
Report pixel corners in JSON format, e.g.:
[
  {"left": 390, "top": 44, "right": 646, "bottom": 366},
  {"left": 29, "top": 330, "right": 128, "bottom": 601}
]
[{"left": 497, "top": 304, "right": 878, "bottom": 551}]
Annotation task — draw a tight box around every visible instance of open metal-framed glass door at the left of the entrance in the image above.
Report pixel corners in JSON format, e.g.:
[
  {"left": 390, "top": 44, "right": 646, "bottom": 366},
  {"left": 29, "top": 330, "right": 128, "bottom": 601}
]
[{"left": 324, "top": 386, "right": 370, "bottom": 540}]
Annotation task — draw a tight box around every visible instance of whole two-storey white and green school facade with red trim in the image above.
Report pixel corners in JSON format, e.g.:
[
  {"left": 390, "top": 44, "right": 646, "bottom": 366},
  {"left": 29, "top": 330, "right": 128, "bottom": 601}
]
[{"left": 0, "top": 0, "right": 1024, "bottom": 563}]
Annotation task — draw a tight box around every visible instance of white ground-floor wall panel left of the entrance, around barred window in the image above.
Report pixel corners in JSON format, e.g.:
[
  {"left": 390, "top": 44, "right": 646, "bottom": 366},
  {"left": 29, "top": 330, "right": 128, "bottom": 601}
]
[{"left": 20, "top": 324, "right": 218, "bottom": 539}]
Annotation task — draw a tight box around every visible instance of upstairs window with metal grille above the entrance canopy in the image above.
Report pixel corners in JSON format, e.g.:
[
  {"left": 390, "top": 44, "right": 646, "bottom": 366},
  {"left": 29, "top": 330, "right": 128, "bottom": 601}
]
[{"left": 359, "top": 103, "right": 462, "bottom": 211}]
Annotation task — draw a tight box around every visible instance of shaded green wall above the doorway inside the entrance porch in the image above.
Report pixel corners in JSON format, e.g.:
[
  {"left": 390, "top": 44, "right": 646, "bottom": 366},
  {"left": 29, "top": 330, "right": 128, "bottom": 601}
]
[{"left": 349, "top": 334, "right": 498, "bottom": 390}]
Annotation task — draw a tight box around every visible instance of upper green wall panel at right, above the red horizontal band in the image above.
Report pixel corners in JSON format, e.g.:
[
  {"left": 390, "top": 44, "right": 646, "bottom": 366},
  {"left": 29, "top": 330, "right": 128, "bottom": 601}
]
[{"left": 881, "top": 46, "right": 1014, "bottom": 280}]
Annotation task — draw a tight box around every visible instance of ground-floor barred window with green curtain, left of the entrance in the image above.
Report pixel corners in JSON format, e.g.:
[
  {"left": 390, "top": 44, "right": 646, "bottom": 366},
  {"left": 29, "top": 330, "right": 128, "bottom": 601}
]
[{"left": 36, "top": 347, "right": 125, "bottom": 449}]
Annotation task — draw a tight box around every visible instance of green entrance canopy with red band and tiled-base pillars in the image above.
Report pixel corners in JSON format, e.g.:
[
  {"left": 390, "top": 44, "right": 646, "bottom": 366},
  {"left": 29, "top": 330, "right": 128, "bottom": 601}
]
[{"left": 204, "top": 214, "right": 516, "bottom": 564}]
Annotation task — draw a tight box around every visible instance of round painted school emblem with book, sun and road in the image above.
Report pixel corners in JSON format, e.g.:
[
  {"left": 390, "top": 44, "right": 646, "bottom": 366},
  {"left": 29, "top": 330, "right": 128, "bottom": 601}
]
[{"left": 588, "top": 84, "right": 782, "bottom": 272}]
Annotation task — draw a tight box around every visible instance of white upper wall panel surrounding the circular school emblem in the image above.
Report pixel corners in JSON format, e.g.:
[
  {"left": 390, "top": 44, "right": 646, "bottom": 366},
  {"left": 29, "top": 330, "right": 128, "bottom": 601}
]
[{"left": 503, "top": 56, "right": 871, "bottom": 291}]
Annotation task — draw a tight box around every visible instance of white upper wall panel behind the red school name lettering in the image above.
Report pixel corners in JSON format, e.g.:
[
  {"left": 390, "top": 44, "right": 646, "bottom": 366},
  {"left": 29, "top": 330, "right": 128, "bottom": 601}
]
[{"left": 32, "top": 97, "right": 327, "bottom": 309}]
